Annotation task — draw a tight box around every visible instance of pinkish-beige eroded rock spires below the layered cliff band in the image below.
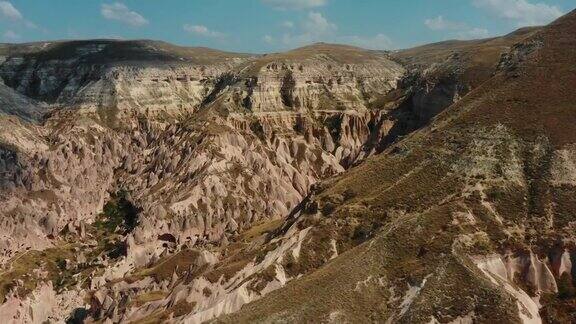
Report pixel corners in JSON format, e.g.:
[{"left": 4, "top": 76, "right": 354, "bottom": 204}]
[{"left": 0, "top": 106, "right": 396, "bottom": 263}]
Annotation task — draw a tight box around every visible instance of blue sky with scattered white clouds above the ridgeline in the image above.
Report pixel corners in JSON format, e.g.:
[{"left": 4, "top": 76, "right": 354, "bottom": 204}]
[{"left": 0, "top": 0, "right": 576, "bottom": 53}]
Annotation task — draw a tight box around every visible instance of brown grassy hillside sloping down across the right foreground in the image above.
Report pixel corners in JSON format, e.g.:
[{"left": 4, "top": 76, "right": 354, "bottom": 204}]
[{"left": 222, "top": 8, "right": 576, "bottom": 323}]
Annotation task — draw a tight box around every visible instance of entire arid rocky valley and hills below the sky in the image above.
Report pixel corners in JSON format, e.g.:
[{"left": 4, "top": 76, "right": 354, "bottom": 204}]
[{"left": 0, "top": 11, "right": 576, "bottom": 323}]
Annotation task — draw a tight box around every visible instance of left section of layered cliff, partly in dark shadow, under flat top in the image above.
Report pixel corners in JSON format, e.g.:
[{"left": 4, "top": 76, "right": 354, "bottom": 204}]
[{"left": 0, "top": 41, "right": 248, "bottom": 122}]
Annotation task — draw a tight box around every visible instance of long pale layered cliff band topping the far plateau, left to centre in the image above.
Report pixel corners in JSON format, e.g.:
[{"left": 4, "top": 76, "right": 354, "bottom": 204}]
[{"left": 0, "top": 41, "right": 404, "bottom": 119}]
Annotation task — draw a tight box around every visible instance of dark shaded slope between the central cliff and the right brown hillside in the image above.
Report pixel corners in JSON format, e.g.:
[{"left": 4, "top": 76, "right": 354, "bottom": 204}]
[{"left": 386, "top": 27, "right": 539, "bottom": 143}]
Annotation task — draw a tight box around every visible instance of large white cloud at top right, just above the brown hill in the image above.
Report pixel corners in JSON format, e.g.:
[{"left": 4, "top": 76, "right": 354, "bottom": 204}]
[{"left": 473, "top": 0, "right": 563, "bottom": 27}]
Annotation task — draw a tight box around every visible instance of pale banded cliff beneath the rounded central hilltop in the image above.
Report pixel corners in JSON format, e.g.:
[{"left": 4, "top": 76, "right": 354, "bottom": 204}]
[{"left": 205, "top": 44, "right": 404, "bottom": 112}]
